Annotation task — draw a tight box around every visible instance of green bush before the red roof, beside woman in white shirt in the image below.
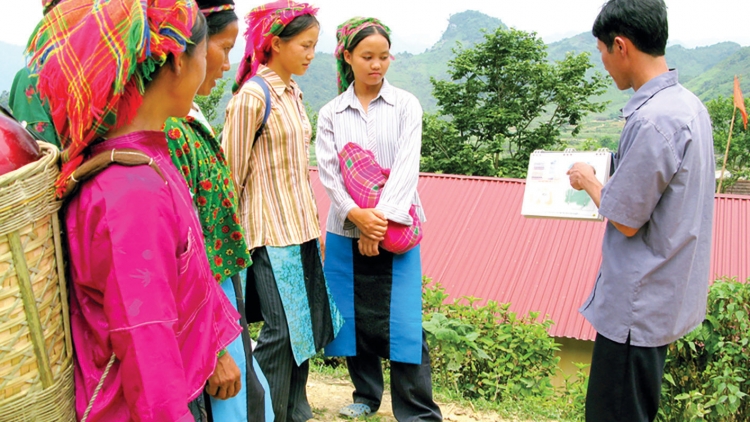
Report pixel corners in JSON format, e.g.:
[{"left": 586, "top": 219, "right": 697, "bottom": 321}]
[{"left": 423, "top": 276, "right": 559, "bottom": 401}]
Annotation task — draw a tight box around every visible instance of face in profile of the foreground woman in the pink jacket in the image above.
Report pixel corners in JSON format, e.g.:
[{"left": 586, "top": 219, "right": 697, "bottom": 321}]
[{"left": 170, "top": 39, "right": 208, "bottom": 117}]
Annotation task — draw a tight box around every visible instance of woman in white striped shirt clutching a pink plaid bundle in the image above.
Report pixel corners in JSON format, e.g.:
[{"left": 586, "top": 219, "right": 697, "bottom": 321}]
[{"left": 315, "top": 18, "right": 442, "bottom": 422}]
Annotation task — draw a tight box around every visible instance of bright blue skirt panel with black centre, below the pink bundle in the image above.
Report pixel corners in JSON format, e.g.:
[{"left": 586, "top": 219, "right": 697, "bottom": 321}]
[{"left": 323, "top": 232, "right": 422, "bottom": 364}]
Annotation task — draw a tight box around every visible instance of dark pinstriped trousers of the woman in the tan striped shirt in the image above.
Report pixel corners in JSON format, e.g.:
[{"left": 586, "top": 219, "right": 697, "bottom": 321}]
[{"left": 247, "top": 247, "right": 313, "bottom": 422}]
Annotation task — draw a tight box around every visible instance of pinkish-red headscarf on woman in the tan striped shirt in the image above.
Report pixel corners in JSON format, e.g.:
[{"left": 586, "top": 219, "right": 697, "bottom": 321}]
[{"left": 232, "top": 0, "right": 318, "bottom": 93}]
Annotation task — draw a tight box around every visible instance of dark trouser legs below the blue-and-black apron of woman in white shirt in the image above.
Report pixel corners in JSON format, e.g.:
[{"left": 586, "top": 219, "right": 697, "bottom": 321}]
[{"left": 346, "top": 331, "right": 443, "bottom": 422}]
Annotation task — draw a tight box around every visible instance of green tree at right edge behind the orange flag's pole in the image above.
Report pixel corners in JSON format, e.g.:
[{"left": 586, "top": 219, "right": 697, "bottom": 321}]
[{"left": 706, "top": 96, "right": 750, "bottom": 191}]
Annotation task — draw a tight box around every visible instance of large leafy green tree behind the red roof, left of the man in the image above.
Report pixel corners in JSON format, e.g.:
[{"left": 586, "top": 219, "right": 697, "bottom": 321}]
[{"left": 422, "top": 28, "right": 607, "bottom": 177}]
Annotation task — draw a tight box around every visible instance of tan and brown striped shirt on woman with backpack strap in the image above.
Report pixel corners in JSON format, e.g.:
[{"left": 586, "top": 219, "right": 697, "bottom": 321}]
[{"left": 222, "top": 66, "right": 320, "bottom": 249}]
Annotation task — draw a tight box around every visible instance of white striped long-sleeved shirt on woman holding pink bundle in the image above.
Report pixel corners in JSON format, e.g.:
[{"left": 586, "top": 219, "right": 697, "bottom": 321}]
[{"left": 315, "top": 79, "right": 425, "bottom": 238}]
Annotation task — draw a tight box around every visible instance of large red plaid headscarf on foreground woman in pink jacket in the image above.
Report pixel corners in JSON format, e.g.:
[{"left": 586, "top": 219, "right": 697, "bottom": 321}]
[{"left": 27, "top": 0, "right": 198, "bottom": 195}]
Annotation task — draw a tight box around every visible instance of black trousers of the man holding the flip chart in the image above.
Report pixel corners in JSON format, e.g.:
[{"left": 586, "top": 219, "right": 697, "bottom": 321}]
[{"left": 586, "top": 334, "right": 667, "bottom": 422}]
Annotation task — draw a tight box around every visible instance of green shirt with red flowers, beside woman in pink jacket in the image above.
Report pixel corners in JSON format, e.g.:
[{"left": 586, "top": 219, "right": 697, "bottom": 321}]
[{"left": 164, "top": 105, "right": 252, "bottom": 282}]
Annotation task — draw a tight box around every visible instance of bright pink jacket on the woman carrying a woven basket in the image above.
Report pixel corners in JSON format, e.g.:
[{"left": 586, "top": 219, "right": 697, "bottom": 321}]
[{"left": 65, "top": 132, "right": 241, "bottom": 422}]
